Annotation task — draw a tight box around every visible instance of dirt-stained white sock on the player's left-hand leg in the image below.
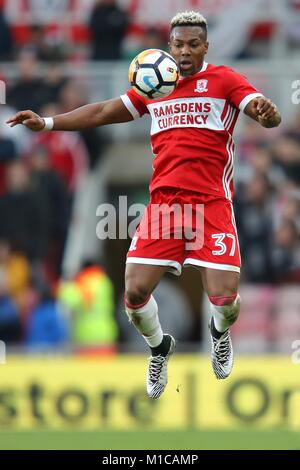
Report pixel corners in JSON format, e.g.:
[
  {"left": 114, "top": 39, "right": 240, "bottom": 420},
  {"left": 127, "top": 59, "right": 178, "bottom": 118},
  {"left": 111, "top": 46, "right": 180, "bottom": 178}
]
[{"left": 125, "top": 295, "right": 163, "bottom": 348}]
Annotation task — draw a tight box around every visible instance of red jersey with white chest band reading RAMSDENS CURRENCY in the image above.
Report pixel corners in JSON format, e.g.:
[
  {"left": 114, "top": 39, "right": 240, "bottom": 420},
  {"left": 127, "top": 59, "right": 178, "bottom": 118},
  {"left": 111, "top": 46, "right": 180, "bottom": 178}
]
[{"left": 121, "top": 62, "right": 262, "bottom": 200}]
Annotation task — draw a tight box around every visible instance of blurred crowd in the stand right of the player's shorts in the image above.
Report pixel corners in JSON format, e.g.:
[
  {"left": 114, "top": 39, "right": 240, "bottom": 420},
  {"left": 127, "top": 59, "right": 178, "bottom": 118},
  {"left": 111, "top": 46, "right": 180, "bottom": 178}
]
[{"left": 235, "top": 112, "right": 300, "bottom": 283}]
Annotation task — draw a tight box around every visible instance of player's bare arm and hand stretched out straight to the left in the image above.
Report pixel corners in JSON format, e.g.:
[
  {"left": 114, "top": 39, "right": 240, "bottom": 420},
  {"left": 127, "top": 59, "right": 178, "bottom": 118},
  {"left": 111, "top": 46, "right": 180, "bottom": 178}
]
[{"left": 6, "top": 98, "right": 133, "bottom": 131}]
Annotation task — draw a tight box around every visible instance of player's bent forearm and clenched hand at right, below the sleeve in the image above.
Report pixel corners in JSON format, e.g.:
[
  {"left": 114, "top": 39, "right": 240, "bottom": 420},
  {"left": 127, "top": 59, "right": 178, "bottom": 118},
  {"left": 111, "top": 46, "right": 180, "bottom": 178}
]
[{"left": 244, "top": 96, "right": 281, "bottom": 127}]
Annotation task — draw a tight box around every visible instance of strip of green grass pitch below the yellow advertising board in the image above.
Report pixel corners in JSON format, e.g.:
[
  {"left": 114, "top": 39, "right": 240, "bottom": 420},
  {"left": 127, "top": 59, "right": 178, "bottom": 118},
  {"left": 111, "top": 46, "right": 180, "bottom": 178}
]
[{"left": 0, "top": 429, "right": 300, "bottom": 450}]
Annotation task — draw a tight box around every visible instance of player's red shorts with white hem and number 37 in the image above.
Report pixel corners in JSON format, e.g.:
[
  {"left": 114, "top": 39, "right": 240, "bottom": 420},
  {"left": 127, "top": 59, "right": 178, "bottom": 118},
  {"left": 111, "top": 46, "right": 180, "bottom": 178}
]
[{"left": 126, "top": 188, "right": 241, "bottom": 275}]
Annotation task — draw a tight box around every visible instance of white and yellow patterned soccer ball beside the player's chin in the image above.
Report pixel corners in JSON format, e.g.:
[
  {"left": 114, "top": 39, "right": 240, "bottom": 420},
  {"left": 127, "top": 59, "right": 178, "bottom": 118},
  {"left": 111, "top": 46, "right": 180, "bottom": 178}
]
[{"left": 128, "top": 49, "right": 179, "bottom": 100}]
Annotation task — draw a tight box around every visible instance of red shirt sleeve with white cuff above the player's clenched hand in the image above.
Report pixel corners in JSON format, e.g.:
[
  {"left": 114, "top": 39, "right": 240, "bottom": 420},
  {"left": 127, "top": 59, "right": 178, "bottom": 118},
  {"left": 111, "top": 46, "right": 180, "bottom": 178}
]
[{"left": 224, "top": 68, "right": 263, "bottom": 111}]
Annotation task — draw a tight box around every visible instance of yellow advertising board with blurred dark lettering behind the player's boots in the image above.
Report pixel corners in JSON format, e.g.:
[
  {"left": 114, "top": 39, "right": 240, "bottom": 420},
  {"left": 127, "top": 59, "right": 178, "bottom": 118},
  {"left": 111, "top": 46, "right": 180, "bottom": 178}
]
[{"left": 0, "top": 355, "right": 300, "bottom": 430}]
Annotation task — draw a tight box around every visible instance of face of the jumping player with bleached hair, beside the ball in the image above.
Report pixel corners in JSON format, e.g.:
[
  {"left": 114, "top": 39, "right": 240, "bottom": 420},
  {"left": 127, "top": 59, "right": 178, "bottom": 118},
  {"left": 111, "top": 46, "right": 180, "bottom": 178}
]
[{"left": 169, "top": 26, "right": 208, "bottom": 77}]
